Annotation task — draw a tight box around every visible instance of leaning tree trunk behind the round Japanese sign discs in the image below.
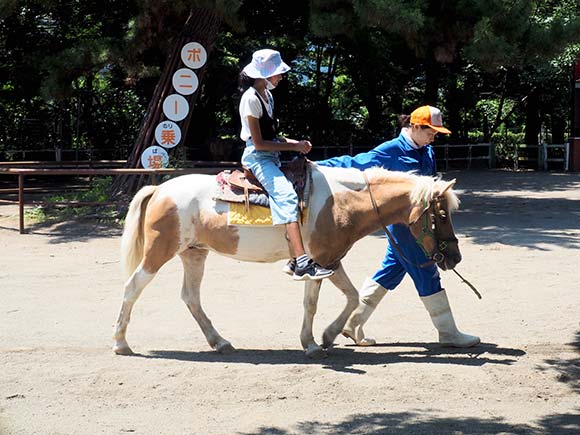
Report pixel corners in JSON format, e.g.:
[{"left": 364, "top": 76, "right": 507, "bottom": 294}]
[{"left": 111, "top": 8, "right": 221, "bottom": 195}]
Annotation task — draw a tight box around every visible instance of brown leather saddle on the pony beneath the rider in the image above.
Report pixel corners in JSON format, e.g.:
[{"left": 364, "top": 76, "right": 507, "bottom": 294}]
[{"left": 214, "top": 155, "right": 310, "bottom": 220}]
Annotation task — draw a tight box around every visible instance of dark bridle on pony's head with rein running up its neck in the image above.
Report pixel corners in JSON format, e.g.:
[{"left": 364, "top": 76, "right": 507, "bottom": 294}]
[{"left": 363, "top": 172, "right": 457, "bottom": 268}]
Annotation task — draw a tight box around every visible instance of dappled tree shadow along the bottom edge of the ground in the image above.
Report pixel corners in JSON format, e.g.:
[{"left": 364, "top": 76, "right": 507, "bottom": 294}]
[{"left": 238, "top": 410, "right": 580, "bottom": 435}]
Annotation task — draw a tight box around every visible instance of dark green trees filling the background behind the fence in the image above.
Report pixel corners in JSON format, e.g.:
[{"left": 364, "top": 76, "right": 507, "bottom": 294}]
[{"left": 0, "top": 0, "right": 580, "bottom": 165}]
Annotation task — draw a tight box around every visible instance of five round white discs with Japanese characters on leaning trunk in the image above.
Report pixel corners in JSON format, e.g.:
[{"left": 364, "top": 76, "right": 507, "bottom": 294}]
[{"left": 141, "top": 42, "right": 207, "bottom": 169}]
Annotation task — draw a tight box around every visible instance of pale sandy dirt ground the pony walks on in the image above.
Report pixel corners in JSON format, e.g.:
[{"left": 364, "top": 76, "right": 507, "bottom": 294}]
[{"left": 0, "top": 171, "right": 580, "bottom": 435}]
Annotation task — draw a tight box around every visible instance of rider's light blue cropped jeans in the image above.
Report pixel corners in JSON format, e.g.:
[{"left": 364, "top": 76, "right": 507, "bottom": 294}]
[{"left": 242, "top": 139, "right": 298, "bottom": 225}]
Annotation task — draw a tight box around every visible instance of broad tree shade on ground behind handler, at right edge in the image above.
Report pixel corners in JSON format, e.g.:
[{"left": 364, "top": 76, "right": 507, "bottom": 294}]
[{"left": 445, "top": 171, "right": 580, "bottom": 250}]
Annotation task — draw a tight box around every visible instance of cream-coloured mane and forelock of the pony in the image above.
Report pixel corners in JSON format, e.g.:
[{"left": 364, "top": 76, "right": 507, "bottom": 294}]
[{"left": 366, "top": 167, "right": 459, "bottom": 211}]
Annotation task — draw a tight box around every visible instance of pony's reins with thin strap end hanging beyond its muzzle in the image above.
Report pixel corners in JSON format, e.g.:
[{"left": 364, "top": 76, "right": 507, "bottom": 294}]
[{"left": 363, "top": 171, "right": 481, "bottom": 299}]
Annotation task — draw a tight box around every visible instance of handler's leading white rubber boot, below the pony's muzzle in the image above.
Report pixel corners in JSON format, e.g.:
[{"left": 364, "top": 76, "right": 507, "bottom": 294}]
[{"left": 421, "top": 290, "right": 481, "bottom": 347}]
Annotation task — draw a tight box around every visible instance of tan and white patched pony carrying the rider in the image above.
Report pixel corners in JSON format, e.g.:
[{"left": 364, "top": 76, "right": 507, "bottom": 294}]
[{"left": 113, "top": 163, "right": 461, "bottom": 358}]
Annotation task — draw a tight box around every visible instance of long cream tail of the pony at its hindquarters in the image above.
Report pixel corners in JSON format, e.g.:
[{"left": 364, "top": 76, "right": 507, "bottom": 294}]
[{"left": 121, "top": 186, "right": 157, "bottom": 280}]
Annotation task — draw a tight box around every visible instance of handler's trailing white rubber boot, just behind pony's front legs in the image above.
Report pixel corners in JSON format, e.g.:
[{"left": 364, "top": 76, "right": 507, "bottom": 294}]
[{"left": 342, "top": 278, "right": 388, "bottom": 346}]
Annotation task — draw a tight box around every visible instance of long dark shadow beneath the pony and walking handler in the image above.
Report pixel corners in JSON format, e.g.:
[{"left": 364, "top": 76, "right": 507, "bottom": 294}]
[{"left": 134, "top": 343, "right": 525, "bottom": 374}]
